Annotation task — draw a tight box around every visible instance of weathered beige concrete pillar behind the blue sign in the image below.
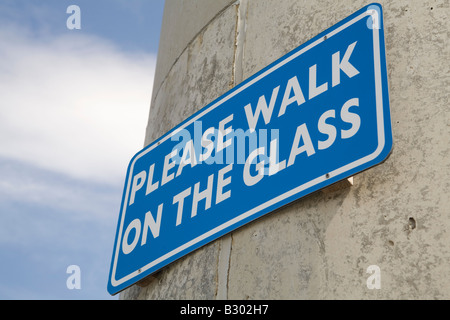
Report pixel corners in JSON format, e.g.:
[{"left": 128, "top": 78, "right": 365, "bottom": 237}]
[{"left": 121, "top": 0, "right": 450, "bottom": 299}]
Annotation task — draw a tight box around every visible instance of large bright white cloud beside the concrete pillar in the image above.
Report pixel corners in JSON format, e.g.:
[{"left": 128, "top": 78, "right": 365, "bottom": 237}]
[{"left": 0, "top": 28, "right": 156, "bottom": 185}]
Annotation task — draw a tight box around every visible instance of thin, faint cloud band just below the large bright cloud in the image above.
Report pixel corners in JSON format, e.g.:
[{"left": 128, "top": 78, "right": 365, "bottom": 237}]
[{"left": 0, "top": 158, "right": 122, "bottom": 222}]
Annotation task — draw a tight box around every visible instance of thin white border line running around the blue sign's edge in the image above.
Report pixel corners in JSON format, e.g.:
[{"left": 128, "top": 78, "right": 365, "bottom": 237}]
[{"left": 111, "top": 6, "right": 385, "bottom": 287}]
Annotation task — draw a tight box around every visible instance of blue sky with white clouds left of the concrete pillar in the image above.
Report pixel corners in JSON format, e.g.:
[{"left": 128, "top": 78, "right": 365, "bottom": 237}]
[{"left": 0, "top": 0, "right": 164, "bottom": 300}]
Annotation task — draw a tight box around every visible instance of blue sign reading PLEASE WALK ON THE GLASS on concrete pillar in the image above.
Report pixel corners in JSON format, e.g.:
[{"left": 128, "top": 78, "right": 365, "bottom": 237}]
[{"left": 108, "top": 4, "right": 392, "bottom": 294}]
